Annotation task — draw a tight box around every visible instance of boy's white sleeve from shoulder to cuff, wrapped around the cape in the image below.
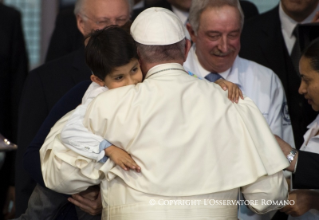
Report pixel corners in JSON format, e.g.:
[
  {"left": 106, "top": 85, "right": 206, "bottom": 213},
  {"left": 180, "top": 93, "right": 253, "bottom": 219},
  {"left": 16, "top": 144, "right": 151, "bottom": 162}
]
[{"left": 61, "top": 82, "right": 108, "bottom": 161}]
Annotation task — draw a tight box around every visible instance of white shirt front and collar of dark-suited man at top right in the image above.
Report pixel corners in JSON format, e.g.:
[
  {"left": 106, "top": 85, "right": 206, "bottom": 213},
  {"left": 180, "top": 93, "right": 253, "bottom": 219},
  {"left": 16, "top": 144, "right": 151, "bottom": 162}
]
[{"left": 279, "top": 3, "right": 319, "bottom": 55}]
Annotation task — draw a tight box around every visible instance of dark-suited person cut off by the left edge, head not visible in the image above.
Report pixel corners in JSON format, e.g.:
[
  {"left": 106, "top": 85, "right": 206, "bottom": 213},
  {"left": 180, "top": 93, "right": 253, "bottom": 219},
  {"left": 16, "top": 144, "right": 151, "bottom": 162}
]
[{"left": 0, "top": 3, "right": 28, "bottom": 219}]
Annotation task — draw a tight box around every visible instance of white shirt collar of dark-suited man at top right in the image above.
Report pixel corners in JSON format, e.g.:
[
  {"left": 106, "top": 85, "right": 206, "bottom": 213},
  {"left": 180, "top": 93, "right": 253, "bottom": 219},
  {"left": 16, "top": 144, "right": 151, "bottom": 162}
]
[{"left": 279, "top": 3, "right": 319, "bottom": 36}]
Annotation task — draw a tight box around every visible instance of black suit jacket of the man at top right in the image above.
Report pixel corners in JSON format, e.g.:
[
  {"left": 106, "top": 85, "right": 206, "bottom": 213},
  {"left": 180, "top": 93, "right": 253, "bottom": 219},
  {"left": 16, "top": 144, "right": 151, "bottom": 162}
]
[{"left": 240, "top": 6, "right": 316, "bottom": 148}]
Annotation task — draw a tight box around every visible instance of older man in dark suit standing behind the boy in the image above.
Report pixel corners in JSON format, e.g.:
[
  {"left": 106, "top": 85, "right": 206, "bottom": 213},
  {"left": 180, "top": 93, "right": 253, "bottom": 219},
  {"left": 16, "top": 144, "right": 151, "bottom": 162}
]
[{"left": 16, "top": 0, "right": 130, "bottom": 216}]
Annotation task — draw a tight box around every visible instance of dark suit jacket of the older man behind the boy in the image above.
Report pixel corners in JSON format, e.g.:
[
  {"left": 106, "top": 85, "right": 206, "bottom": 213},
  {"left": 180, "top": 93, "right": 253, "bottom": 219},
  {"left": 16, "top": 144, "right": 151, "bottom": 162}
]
[{"left": 16, "top": 47, "right": 91, "bottom": 216}]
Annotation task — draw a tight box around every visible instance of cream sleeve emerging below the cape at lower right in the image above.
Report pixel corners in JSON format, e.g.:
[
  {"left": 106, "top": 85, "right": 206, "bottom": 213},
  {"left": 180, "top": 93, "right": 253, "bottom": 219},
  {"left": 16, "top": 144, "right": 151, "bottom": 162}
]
[{"left": 241, "top": 171, "right": 288, "bottom": 214}]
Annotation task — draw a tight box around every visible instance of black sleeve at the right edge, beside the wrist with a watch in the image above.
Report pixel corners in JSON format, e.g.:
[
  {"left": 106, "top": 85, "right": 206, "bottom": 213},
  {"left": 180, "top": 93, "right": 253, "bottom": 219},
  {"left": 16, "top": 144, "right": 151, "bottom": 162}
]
[{"left": 293, "top": 151, "right": 319, "bottom": 189}]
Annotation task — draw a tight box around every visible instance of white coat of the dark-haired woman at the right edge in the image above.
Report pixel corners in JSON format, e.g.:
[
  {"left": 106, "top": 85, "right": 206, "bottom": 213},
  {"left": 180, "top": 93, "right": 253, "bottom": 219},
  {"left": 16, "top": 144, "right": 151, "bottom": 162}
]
[{"left": 288, "top": 115, "right": 319, "bottom": 220}]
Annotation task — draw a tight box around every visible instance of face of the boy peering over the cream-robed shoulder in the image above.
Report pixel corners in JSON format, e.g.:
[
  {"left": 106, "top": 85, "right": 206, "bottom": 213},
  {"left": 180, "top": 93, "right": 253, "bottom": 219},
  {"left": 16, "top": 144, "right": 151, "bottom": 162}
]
[{"left": 92, "top": 59, "right": 143, "bottom": 89}]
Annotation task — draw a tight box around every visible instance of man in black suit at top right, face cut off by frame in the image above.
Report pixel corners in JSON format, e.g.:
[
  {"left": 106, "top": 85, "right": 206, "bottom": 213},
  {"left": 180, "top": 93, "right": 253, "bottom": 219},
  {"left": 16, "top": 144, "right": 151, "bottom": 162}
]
[{"left": 239, "top": 0, "right": 319, "bottom": 148}]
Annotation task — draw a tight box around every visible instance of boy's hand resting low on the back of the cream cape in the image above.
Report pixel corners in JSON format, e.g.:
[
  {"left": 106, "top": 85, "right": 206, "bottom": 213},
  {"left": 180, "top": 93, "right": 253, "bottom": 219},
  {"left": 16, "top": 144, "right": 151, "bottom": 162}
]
[{"left": 105, "top": 146, "right": 141, "bottom": 173}]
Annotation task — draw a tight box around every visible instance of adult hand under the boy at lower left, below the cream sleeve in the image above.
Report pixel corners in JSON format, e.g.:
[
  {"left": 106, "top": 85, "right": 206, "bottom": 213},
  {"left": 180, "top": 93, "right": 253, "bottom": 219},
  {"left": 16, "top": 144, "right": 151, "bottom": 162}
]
[{"left": 68, "top": 186, "right": 103, "bottom": 215}]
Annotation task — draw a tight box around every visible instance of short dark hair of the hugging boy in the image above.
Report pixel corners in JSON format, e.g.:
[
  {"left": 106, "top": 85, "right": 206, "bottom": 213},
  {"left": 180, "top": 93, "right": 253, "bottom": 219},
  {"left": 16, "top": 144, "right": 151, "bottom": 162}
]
[{"left": 85, "top": 25, "right": 138, "bottom": 80}]
